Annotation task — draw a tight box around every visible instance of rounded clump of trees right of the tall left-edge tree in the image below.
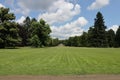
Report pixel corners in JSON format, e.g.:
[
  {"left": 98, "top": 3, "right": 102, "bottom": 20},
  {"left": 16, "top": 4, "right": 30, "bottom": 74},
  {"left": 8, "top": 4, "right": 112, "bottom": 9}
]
[{"left": 18, "top": 17, "right": 51, "bottom": 47}]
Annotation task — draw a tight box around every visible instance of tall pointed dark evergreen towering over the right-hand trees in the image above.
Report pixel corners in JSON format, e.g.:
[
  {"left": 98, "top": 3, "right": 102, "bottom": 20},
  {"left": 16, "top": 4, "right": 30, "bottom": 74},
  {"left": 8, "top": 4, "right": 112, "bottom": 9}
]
[{"left": 89, "top": 12, "right": 108, "bottom": 47}]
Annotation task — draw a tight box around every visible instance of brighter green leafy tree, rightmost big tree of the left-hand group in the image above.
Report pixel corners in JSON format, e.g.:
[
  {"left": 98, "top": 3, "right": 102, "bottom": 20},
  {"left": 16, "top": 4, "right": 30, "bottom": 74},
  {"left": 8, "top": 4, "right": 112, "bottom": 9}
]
[{"left": 30, "top": 19, "right": 51, "bottom": 47}]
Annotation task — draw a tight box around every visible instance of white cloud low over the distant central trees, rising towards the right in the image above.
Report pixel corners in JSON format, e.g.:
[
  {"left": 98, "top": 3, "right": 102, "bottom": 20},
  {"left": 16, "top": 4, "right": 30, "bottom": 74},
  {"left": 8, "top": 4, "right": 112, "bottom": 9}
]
[{"left": 51, "top": 17, "right": 88, "bottom": 39}]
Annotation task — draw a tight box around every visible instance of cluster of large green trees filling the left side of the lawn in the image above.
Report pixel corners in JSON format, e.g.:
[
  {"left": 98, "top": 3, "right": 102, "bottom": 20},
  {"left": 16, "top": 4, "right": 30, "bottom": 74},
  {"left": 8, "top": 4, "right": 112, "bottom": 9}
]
[{"left": 0, "top": 7, "right": 54, "bottom": 48}]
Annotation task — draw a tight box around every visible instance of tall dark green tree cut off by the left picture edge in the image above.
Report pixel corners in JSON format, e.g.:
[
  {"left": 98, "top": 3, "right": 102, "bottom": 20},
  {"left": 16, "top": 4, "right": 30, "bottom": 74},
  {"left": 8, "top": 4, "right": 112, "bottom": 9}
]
[{"left": 0, "top": 8, "right": 20, "bottom": 48}]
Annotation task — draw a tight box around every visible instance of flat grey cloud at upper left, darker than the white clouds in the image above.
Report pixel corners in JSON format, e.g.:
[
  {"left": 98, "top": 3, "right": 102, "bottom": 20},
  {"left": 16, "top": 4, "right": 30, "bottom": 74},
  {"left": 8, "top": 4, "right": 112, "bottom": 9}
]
[{"left": 15, "top": 0, "right": 57, "bottom": 15}]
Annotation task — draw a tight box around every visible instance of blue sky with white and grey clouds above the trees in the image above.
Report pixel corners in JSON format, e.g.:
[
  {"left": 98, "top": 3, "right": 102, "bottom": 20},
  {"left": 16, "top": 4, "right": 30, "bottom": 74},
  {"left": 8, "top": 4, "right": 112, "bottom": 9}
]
[{"left": 0, "top": 0, "right": 120, "bottom": 39}]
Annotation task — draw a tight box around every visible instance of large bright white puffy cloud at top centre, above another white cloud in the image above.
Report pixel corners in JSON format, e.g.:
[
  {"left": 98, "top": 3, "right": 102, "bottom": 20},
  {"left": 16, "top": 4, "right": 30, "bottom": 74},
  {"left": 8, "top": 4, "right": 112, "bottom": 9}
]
[{"left": 38, "top": 0, "right": 80, "bottom": 24}]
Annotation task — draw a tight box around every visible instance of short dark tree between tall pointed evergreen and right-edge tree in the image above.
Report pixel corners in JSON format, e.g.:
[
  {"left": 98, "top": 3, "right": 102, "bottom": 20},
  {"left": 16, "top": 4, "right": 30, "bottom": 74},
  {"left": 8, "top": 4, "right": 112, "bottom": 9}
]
[{"left": 107, "top": 29, "right": 115, "bottom": 47}]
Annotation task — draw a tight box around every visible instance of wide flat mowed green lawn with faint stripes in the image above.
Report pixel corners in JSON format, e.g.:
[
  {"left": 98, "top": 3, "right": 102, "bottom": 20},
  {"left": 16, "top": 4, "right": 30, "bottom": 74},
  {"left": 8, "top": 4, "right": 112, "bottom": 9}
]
[{"left": 0, "top": 47, "right": 120, "bottom": 75}]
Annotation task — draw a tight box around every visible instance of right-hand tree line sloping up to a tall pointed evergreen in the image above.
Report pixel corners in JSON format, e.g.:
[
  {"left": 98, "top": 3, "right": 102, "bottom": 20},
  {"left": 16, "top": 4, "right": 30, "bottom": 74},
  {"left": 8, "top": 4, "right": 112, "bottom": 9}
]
[{"left": 64, "top": 12, "right": 120, "bottom": 47}]
